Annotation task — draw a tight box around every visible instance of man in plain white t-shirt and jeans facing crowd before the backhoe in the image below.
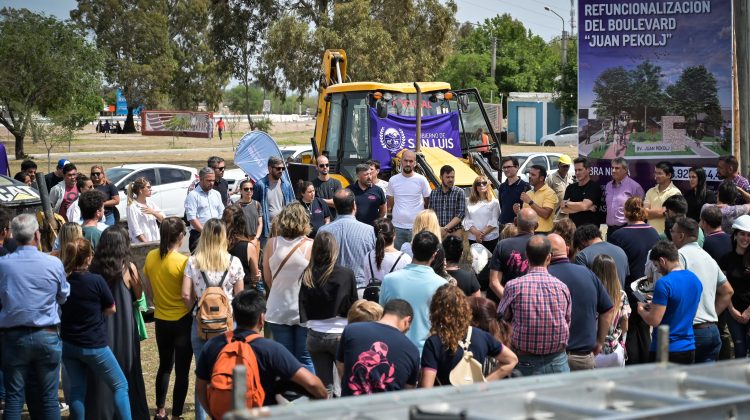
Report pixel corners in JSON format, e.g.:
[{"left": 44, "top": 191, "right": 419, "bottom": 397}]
[{"left": 386, "top": 150, "right": 432, "bottom": 249}]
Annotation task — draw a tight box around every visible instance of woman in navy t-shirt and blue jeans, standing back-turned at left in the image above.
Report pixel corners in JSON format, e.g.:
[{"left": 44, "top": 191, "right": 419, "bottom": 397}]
[{"left": 60, "top": 238, "right": 132, "bottom": 420}]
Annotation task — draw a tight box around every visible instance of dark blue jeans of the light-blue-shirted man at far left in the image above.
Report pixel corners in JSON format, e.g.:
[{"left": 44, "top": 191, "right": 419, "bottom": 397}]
[{"left": 1, "top": 327, "right": 62, "bottom": 420}]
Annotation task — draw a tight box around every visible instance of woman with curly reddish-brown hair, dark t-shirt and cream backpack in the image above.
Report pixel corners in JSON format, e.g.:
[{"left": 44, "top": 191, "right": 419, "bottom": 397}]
[{"left": 419, "top": 284, "right": 518, "bottom": 388}]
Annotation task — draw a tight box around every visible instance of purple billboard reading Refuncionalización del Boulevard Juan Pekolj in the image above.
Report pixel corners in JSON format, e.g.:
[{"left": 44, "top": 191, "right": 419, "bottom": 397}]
[{"left": 578, "top": 0, "right": 732, "bottom": 190}]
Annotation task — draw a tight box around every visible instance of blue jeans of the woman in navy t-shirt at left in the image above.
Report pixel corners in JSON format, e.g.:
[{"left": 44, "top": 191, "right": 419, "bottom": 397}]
[{"left": 62, "top": 342, "right": 131, "bottom": 420}]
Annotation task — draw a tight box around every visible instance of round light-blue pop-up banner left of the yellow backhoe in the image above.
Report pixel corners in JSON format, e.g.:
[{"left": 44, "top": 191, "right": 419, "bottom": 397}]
[{"left": 234, "top": 131, "right": 292, "bottom": 184}]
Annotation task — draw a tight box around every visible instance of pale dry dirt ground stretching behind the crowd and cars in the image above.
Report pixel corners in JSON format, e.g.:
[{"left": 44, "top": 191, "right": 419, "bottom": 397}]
[{"left": 0, "top": 121, "right": 578, "bottom": 174}]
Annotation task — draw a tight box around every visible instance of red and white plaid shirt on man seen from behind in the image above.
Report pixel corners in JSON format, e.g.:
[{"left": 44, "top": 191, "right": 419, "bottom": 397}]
[{"left": 497, "top": 267, "right": 571, "bottom": 355}]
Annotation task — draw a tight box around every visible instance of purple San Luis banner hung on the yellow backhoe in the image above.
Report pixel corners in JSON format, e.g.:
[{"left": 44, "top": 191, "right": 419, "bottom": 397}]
[{"left": 370, "top": 108, "right": 461, "bottom": 170}]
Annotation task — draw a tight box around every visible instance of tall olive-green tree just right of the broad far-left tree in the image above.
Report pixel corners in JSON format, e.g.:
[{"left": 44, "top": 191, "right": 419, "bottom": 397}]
[{"left": 70, "top": 0, "right": 177, "bottom": 133}]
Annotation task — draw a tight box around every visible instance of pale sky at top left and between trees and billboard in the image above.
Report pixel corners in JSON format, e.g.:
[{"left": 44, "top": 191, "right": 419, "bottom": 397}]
[{"left": 0, "top": 0, "right": 577, "bottom": 41}]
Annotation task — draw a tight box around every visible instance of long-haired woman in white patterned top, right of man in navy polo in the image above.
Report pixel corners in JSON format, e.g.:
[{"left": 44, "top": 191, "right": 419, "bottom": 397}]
[{"left": 591, "top": 254, "right": 630, "bottom": 368}]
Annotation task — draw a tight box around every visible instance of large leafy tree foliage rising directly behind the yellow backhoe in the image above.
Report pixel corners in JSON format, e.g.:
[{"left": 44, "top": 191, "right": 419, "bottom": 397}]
[{"left": 262, "top": 0, "right": 456, "bottom": 96}]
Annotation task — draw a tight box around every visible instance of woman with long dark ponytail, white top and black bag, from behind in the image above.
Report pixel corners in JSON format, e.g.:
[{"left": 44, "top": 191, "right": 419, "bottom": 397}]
[{"left": 363, "top": 217, "right": 411, "bottom": 283}]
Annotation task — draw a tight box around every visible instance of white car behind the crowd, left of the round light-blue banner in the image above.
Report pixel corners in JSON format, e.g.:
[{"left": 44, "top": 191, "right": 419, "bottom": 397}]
[{"left": 105, "top": 163, "right": 198, "bottom": 220}]
